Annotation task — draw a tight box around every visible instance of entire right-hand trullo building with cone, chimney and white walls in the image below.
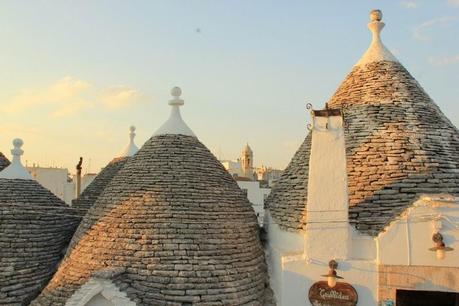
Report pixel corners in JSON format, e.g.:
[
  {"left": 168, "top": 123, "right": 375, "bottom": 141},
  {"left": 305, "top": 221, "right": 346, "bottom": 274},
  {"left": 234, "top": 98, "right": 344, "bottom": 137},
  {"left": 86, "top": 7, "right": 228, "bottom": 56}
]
[{"left": 265, "top": 10, "right": 459, "bottom": 306}]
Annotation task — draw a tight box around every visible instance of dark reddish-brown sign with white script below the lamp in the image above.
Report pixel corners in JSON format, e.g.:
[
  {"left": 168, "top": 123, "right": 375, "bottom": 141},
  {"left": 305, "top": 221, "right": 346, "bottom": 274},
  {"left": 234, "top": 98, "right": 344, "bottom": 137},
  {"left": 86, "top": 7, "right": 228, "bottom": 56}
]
[{"left": 309, "top": 281, "right": 358, "bottom": 306}]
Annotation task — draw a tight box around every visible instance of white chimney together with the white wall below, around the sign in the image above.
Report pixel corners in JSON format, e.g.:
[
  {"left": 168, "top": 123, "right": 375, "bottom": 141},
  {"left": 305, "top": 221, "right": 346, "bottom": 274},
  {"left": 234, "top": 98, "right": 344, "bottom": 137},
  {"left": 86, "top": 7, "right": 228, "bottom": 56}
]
[{"left": 265, "top": 116, "right": 378, "bottom": 306}]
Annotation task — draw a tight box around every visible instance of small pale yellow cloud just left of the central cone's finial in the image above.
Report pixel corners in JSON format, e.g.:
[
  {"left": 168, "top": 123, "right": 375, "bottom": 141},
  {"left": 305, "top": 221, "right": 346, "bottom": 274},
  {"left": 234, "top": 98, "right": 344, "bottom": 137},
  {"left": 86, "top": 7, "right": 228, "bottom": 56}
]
[{"left": 100, "top": 86, "right": 143, "bottom": 109}]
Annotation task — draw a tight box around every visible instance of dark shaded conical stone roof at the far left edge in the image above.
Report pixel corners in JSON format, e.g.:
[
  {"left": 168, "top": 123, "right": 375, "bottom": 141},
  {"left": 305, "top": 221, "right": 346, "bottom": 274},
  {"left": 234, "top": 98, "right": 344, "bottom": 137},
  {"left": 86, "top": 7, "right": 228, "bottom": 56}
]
[{"left": 0, "top": 142, "right": 80, "bottom": 305}]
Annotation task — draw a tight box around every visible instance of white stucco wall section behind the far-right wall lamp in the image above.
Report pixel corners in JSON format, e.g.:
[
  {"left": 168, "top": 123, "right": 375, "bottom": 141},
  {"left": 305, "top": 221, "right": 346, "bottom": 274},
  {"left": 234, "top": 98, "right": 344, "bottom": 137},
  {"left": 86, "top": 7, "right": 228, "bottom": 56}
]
[{"left": 378, "top": 196, "right": 459, "bottom": 267}]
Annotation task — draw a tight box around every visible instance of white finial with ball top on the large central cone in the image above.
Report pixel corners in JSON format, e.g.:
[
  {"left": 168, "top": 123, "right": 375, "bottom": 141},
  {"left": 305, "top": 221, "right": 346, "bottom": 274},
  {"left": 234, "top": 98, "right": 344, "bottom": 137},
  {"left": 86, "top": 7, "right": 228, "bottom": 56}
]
[{"left": 154, "top": 86, "right": 196, "bottom": 137}]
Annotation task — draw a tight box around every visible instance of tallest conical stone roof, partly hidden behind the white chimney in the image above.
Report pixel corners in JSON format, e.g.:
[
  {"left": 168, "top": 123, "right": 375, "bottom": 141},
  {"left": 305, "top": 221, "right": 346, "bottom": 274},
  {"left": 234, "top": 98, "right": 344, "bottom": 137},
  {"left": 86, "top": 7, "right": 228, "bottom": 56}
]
[{"left": 267, "top": 9, "right": 459, "bottom": 235}]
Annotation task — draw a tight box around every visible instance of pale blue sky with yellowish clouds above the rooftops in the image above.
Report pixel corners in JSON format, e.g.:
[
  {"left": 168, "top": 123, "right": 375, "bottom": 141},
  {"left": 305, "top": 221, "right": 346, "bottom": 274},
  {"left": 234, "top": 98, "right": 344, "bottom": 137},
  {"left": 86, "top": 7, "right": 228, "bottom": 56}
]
[{"left": 0, "top": 0, "right": 459, "bottom": 171}]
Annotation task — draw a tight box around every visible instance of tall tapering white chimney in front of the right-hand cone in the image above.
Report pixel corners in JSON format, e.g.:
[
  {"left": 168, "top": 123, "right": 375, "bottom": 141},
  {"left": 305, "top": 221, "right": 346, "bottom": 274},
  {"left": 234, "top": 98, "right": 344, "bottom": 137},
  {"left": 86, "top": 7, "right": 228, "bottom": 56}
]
[{"left": 305, "top": 105, "right": 350, "bottom": 262}]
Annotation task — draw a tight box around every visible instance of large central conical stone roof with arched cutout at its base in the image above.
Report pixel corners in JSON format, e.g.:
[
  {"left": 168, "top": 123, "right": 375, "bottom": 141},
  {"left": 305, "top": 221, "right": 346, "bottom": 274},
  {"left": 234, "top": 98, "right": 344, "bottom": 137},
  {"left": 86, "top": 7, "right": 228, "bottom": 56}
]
[{"left": 32, "top": 89, "right": 267, "bottom": 306}]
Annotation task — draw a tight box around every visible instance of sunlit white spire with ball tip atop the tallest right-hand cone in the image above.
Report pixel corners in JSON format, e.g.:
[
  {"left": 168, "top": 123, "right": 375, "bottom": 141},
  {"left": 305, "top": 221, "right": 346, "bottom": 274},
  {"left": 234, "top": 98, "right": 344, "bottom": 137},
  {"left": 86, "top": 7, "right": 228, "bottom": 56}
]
[{"left": 356, "top": 10, "right": 398, "bottom": 66}]
